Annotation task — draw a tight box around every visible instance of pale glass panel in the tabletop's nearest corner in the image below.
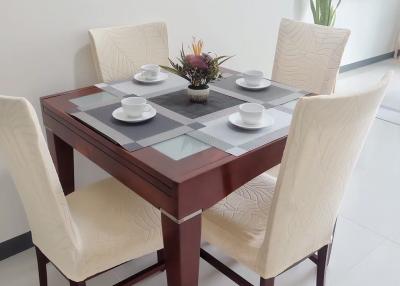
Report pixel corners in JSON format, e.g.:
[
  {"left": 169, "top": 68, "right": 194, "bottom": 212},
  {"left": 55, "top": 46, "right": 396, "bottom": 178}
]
[{"left": 152, "top": 135, "right": 211, "bottom": 160}]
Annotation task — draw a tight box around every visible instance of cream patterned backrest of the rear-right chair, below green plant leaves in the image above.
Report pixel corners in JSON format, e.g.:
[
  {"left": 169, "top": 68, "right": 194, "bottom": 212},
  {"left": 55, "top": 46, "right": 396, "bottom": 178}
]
[{"left": 272, "top": 19, "right": 350, "bottom": 94}]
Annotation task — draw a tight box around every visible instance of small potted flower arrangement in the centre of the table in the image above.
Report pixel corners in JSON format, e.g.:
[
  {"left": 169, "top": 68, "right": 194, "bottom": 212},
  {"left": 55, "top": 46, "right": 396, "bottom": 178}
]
[{"left": 162, "top": 39, "right": 231, "bottom": 102}]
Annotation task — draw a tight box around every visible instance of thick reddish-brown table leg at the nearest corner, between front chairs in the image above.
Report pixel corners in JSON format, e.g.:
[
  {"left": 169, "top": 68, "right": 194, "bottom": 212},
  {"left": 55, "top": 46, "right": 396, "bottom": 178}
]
[{"left": 161, "top": 212, "right": 201, "bottom": 286}]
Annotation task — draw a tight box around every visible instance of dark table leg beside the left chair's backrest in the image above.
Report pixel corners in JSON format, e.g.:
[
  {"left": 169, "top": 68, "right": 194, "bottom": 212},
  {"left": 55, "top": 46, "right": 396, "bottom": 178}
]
[{"left": 46, "top": 129, "right": 75, "bottom": 195}]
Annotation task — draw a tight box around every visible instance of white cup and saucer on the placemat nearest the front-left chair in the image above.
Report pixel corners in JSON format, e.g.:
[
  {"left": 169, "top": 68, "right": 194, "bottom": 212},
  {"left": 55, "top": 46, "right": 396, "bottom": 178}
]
[{"left": 112, "top": 97, "right": 157, "bottom": 123}]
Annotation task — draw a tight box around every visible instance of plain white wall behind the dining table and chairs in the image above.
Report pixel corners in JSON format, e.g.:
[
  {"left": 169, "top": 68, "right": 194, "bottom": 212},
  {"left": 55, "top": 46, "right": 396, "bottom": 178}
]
[{"left": 0, "top": 0, "right": 400, "bottom": 242}]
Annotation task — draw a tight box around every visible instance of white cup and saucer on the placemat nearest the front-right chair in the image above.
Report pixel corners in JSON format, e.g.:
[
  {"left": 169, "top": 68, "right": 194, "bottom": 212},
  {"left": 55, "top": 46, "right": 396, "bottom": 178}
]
[{"left": 229, "top": 103, "right": 274, "bottom": 130}]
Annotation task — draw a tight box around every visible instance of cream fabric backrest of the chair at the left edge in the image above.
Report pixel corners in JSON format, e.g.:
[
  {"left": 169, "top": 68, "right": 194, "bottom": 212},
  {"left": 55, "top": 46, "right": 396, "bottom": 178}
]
[{"left": 0, "top": 96, "right": 77, "bottom": 253}]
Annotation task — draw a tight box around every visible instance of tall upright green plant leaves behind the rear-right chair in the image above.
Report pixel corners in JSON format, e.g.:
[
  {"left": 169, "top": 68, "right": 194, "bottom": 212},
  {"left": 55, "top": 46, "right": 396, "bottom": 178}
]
[{"left": 310, "top": 0, "right": 342, "bottom": 27}]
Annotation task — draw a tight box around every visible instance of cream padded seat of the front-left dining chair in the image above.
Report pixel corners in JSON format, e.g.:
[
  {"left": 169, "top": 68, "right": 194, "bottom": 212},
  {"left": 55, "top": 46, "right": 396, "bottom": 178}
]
[{"left": 63, "top": 178, "right": 163, "bottom": 281}]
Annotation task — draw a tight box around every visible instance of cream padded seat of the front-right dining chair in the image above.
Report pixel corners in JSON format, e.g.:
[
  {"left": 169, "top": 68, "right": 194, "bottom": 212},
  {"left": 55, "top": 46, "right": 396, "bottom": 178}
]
[{"left": 203, "top": 173, "right": 276, "bottom": 270}]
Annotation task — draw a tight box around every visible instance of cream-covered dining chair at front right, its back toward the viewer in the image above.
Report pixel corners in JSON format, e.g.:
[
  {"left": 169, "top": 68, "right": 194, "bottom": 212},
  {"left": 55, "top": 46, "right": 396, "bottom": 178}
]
[{"left": 201, "top": 74, "right": 391, "bottom": 286}]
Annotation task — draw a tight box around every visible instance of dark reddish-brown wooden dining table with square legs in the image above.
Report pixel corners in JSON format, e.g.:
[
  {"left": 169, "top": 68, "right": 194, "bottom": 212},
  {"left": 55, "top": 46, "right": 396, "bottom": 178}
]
[{"left": 41, "top": 73, "right": 286, "bottom": 286}]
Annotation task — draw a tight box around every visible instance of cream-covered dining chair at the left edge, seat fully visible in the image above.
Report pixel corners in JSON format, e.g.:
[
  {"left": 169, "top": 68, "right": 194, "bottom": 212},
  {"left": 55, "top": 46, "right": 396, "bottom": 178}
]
[{"left": 0, "top": 96, "right": 164, "bottom": 286}]
